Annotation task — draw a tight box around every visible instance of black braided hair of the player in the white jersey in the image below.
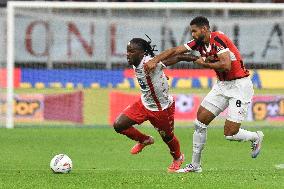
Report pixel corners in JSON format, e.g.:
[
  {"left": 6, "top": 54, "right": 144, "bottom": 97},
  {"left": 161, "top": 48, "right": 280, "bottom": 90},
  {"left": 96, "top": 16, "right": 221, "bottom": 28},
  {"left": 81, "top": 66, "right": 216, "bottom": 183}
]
[{"left": 130, "top": 34, "right": 157, "bottom": 57}]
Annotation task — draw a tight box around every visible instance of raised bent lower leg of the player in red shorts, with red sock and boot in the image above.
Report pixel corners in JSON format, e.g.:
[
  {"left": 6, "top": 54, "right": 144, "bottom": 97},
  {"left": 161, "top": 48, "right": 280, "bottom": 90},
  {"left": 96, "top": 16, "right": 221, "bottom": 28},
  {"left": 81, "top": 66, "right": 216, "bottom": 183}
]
[{"left": 113, "top": 114, "right": 154, "bottom": 154}]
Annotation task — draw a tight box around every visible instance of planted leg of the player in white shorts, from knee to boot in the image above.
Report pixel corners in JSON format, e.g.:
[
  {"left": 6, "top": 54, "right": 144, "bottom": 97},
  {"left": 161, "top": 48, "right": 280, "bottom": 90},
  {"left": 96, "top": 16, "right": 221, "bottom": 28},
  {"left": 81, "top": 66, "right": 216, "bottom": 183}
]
[{"left": 177, "top": 106, "right": 215, "bottom": 173}]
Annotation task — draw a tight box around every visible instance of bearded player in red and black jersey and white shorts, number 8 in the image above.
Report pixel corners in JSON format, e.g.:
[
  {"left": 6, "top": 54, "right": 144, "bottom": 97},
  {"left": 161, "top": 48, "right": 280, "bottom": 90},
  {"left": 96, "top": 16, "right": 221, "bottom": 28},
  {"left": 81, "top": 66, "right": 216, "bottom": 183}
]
[{"left": 145, "top": 16, "right": 264, "bottom": 173}]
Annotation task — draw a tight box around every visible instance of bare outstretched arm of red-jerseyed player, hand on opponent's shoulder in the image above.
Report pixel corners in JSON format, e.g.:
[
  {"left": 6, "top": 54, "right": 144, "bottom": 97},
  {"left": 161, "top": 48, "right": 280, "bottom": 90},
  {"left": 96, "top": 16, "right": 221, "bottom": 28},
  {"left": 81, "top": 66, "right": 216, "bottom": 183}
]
[{"left": 144, "top": 45, "right": 188, "bottom": 73}]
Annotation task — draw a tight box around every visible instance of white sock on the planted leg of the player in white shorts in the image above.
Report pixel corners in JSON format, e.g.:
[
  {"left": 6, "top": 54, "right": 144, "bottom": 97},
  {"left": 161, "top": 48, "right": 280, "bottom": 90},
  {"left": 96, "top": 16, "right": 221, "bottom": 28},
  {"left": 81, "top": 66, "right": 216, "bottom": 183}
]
[{"left": 191, "top": 120, "right": 207, "bottom": 167}]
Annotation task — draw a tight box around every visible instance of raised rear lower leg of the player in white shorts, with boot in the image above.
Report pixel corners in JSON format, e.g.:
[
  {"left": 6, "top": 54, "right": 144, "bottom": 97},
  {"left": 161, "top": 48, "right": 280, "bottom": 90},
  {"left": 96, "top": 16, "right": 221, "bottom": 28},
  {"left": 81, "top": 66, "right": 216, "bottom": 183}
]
[{"left": 224, "top": 120, "right": 264, "bottom": 158}]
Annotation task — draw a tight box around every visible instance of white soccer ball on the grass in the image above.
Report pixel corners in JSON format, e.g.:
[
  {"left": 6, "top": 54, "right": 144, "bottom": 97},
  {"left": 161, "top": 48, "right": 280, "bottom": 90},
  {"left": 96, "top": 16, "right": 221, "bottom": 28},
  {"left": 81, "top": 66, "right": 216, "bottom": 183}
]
[{"left": 50, "top": 154, "right": 72, "bottom": 173}]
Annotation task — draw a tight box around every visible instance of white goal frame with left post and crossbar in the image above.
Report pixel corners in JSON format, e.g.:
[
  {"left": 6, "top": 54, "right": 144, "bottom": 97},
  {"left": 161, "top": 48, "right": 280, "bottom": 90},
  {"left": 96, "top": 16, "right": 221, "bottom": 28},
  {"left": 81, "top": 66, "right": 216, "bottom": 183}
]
[{"left": 5, "top": 1, "right": 284, "bottom": 128}]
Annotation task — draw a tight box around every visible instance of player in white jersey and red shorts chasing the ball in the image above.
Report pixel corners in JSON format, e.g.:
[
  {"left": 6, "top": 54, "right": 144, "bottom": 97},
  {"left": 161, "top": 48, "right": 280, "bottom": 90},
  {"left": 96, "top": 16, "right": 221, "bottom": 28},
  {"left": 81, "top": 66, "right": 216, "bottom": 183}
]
[{"left": 113, "top": 38, "right": 196, "bottom": 172}]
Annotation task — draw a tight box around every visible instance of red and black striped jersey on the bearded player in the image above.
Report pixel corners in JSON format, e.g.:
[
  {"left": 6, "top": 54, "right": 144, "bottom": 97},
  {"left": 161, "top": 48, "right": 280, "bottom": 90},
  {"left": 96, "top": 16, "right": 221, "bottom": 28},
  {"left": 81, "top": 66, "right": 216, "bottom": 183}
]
[{"left": 184, "top": 32, "right": 249, "bottom": 81}]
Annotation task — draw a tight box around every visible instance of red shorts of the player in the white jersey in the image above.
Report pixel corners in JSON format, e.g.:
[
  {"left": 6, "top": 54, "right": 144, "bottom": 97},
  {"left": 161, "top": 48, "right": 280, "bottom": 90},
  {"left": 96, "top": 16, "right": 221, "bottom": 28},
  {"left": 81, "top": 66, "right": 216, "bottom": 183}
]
[{"left": 122, "top": 99, "right": 175, "bottom": 136}]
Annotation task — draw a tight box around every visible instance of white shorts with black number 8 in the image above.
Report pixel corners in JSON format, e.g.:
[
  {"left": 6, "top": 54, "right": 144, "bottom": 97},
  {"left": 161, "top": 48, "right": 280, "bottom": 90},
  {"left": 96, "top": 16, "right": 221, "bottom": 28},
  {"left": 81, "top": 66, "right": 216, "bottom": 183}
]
[{"left": 201, "top": 77, "right": 254, "bottom": 123}]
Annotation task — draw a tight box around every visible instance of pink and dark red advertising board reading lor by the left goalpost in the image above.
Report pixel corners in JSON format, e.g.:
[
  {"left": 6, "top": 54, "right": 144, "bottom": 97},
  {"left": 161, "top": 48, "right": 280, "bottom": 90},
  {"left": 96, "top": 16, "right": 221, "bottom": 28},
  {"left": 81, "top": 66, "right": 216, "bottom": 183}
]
[{"left": 0, "top": 91, "right": 84, "bottom": 124}]
